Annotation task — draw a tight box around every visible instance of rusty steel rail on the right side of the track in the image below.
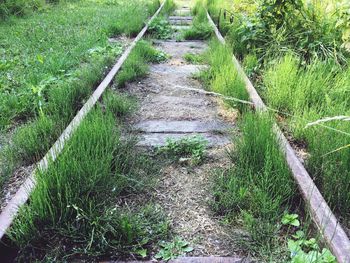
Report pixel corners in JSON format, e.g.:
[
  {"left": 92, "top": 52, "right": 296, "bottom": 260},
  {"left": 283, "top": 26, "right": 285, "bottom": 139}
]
[{"left": 207, "top": 9, "right": 350, "bottom": 263}]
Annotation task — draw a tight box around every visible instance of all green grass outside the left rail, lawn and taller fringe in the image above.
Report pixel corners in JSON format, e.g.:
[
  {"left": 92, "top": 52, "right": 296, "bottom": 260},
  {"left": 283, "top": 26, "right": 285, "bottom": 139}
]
[{"left": 0, "top": 1, "right": 160, "bottom": 194}]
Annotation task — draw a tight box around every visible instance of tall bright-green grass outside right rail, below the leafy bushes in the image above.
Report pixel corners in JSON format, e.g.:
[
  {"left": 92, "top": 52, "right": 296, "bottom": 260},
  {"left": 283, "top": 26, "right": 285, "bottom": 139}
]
[{"left": 263, "top": 55, "right": 350, "bottom": 218}]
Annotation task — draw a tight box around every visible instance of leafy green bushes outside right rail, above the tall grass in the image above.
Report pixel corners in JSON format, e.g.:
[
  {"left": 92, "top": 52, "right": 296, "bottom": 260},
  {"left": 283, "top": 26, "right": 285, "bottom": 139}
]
[{"left": 209, "top": 0, "right": 346, "bottom": 63}]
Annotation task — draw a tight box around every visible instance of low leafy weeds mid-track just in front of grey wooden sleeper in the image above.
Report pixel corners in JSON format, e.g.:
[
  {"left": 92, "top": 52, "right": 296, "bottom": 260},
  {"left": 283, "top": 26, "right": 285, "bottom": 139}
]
[{"left": 158, "top": 135, "right": 208, "bottom": 165}]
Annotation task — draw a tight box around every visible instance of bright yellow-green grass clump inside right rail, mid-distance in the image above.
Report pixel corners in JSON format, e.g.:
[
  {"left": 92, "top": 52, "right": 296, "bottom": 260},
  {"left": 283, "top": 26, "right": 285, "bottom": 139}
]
[{"left": 199, "top": 40, "right": 249, "bottom": 111}]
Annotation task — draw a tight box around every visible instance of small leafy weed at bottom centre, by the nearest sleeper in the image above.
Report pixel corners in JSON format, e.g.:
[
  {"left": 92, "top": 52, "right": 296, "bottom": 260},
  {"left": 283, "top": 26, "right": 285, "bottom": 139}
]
[{"left": 155, "top": 237, "right": 193, "bottom": 261}]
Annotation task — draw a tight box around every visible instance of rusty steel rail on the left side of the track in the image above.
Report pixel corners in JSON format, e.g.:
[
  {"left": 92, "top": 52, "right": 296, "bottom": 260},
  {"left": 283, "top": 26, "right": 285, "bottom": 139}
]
[{"left": 0, "top": 0, "right": 167, "bottom": 239}]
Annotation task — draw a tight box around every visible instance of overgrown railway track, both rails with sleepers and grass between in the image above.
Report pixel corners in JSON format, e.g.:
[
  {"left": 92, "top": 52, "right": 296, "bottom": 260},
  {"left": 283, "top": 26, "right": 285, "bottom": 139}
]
[{"left": 0, "top": 0, "right": 348, "bottom": 262}]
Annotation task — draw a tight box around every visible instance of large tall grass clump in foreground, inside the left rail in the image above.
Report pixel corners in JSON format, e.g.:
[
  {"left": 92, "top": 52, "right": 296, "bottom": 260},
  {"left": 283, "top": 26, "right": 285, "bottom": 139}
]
[{"left": 9, "top": 104, "right": 168, "bottom": 260}]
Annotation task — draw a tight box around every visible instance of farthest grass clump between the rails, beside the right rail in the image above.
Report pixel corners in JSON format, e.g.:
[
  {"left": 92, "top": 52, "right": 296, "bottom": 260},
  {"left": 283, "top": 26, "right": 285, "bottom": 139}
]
[{"left": 182, "top": 1, "right": 213, "bottom": 40}]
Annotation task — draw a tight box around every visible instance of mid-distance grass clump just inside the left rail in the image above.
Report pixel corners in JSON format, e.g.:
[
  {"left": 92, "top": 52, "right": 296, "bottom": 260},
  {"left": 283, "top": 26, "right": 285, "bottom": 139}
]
[{"left": 117, "top": 41, "right": 167, "bottom": 87}]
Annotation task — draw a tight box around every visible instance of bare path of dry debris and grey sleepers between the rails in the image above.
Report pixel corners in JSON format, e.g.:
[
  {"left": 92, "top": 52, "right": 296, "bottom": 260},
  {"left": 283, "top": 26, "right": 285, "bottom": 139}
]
[{"left": 120, "top": 2, "right": 249, "bottom": 262}]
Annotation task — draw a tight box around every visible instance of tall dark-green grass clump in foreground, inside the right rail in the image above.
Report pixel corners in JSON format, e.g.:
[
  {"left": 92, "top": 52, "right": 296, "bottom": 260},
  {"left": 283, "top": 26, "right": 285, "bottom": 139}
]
[{"left": 212, "top": 113, "right": 296, "bottom": 256}]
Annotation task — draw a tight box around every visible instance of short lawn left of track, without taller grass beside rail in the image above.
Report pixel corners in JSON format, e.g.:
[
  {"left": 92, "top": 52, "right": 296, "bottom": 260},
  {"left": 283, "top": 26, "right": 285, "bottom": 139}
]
[{"left": 0, "top": 1, "right": 159, "bottom": 129}]
